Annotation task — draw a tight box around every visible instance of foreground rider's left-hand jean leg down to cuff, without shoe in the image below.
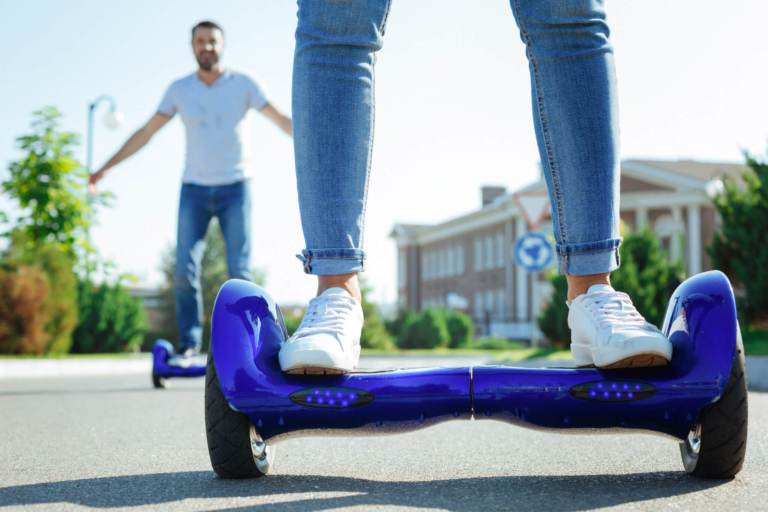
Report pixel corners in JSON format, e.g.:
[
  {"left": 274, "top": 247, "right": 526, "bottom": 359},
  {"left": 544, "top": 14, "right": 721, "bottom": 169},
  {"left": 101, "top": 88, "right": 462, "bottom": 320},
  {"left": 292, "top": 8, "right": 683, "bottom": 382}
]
[{"left": 293, "top": 0, "right": 390, "bottom": 276}]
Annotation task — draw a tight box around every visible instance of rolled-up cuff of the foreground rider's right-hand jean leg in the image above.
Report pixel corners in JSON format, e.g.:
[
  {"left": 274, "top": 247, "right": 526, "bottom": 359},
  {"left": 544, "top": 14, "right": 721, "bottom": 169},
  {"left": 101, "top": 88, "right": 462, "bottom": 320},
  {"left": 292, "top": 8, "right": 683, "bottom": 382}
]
[{"left": 555, "top": 237, "right": 623, "bottom": 276}]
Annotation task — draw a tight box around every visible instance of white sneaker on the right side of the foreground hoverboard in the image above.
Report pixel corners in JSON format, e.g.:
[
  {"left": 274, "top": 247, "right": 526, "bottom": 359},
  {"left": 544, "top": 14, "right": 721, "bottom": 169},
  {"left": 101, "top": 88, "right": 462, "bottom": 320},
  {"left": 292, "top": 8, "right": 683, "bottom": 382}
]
[{"left": 568, "top": 284, "right": 672, "bottom": 368}]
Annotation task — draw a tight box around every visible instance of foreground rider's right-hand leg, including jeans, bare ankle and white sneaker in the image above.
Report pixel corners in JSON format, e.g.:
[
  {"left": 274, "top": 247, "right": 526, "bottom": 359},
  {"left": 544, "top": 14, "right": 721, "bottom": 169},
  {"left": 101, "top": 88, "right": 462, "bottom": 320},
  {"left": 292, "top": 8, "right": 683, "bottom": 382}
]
[{"left": 510, "top": 0, "right": 672, "bottom": 368}]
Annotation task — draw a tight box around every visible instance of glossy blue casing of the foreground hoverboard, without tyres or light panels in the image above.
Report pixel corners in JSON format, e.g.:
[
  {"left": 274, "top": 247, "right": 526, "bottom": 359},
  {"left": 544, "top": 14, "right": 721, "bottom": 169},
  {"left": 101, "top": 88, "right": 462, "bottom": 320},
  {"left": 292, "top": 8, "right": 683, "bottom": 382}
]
[{"left": 211, "top": 272, "right": 738, "bottom": 444}]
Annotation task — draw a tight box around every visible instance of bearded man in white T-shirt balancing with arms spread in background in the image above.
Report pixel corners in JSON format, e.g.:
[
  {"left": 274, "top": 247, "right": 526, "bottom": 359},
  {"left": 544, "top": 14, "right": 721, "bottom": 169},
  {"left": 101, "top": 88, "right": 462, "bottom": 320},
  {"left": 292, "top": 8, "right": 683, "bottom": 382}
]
[{"left": 89, "top": 21, "right": 292, "bottom": 365}]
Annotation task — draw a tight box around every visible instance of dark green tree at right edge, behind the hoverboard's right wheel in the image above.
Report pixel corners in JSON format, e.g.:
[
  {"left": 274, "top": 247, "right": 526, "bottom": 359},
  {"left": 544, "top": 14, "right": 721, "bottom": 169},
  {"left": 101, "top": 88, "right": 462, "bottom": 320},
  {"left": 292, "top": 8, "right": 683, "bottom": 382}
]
[{"left": 708, "top": 153, "right": 768, "bottom": 329}]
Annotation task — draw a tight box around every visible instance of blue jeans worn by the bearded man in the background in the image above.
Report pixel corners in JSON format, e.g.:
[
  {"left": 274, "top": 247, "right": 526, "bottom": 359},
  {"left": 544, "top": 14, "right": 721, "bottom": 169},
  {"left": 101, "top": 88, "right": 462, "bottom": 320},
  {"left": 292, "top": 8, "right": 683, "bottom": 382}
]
[{"left": 175, "top": 181, "right": 253, "bottom": 351}]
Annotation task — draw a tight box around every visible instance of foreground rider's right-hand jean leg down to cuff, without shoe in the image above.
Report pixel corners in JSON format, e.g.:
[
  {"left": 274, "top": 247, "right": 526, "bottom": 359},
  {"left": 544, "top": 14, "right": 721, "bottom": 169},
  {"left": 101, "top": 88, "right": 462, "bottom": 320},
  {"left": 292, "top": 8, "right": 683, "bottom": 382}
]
[{"left": 511, "top": 0, "right": 621, "bottom": 276}]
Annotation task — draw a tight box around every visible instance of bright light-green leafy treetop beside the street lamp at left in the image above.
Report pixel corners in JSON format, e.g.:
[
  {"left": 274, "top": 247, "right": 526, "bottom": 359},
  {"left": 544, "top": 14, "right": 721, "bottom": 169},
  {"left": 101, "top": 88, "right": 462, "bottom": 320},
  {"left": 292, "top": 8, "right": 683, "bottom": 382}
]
[{"left": 2, "top": 107, "right": 111, "bottom": 263}]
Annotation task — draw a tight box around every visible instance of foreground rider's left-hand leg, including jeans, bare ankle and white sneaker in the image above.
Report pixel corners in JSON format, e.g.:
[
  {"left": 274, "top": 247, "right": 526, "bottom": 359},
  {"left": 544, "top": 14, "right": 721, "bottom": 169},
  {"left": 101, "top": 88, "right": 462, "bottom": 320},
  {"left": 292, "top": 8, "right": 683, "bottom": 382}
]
[{"left": 280, "top": 0, "right": 390, "bottom": 373}]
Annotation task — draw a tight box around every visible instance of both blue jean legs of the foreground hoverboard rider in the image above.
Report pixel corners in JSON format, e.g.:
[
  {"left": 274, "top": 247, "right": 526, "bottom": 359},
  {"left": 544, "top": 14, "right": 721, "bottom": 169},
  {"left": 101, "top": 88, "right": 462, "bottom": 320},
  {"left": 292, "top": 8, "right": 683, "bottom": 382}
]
[{"left": 293, "top": 0, "right": 621, "bottom": 275}]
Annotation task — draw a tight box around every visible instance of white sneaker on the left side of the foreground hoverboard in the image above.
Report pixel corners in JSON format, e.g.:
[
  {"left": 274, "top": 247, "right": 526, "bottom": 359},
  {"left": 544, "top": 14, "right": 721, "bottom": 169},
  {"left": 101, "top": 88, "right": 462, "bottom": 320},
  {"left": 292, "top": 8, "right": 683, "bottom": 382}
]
[{"left": 278, "top": 288, "right": 363, "bottom": 375}]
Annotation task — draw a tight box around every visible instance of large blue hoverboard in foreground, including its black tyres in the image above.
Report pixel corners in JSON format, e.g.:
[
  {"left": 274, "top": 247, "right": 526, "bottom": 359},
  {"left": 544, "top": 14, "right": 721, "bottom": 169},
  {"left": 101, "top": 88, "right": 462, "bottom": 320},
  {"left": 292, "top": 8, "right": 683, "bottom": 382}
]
[{"left": 205, "top": 272, "right": 747, "bottom": 478}]
